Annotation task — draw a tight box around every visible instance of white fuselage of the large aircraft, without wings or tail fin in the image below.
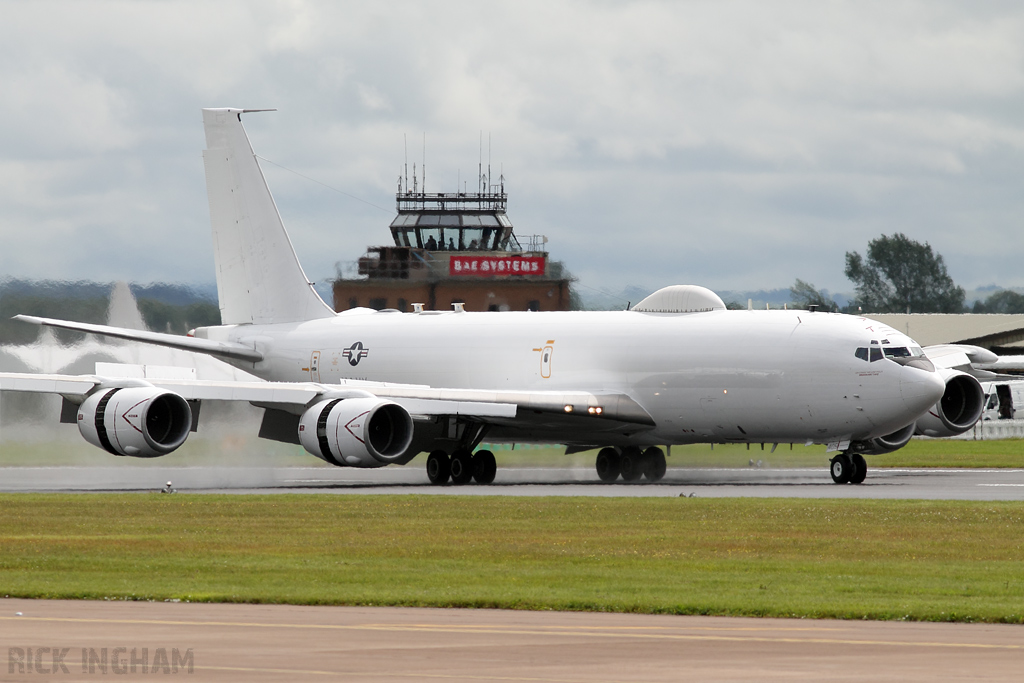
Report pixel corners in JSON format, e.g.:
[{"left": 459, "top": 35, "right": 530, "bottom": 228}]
[{"left": 197, "top": 309, "right": 944, "bottom": 443}]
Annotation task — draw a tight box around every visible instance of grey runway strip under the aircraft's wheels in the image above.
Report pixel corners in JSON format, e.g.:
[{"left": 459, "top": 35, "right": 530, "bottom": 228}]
[{"left": 6, "top": 465, "right": 1024, "bottom": 501}]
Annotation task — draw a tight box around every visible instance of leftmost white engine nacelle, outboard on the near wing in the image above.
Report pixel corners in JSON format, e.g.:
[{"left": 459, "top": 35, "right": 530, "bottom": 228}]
[{"left": 78, "top": 387, "right": 191, "bottom": 458}]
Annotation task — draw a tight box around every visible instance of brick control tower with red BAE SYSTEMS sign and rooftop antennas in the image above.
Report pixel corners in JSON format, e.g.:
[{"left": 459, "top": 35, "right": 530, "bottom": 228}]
[{"left": 334, "top": 173, "right": 571, "bottom": 311}]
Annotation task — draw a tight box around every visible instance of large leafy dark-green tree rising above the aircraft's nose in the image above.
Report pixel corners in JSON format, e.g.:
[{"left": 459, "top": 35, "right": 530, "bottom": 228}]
[{"left": 846, "top": 232, "right": 966, "bottom": 313}]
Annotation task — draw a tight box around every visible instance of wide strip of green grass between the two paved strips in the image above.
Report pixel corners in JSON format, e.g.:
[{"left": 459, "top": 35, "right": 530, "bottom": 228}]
[{"left": 0, "top": 494, "right": 1024, "bottom": 623}]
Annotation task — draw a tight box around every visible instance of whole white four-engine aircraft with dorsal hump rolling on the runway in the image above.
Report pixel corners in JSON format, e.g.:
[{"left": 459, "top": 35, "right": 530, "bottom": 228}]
[{"left": 0, "top": 109, "right": 994, "bottom": 484}]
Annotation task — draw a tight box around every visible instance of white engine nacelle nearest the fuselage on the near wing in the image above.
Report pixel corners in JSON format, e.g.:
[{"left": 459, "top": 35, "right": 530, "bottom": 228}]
[{"left": 299, "top": 397, "right": 413, "bottom": 467}]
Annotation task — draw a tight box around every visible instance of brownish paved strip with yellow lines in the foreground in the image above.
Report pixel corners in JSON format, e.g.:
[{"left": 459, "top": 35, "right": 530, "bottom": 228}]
[{"left": 0, "top": 600, "right": 1024, "bottom": 683}]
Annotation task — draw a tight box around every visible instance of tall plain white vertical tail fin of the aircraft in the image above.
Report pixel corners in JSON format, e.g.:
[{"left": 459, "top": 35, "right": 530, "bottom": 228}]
[{"left": 203, "top": 109, "right": 335, "bottom": 325}]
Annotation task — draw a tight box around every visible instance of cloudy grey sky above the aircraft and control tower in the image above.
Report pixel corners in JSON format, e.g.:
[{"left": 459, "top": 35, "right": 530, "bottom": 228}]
[{"left": 0, "top": 0, "right": 1024, "bottom": 301}]
